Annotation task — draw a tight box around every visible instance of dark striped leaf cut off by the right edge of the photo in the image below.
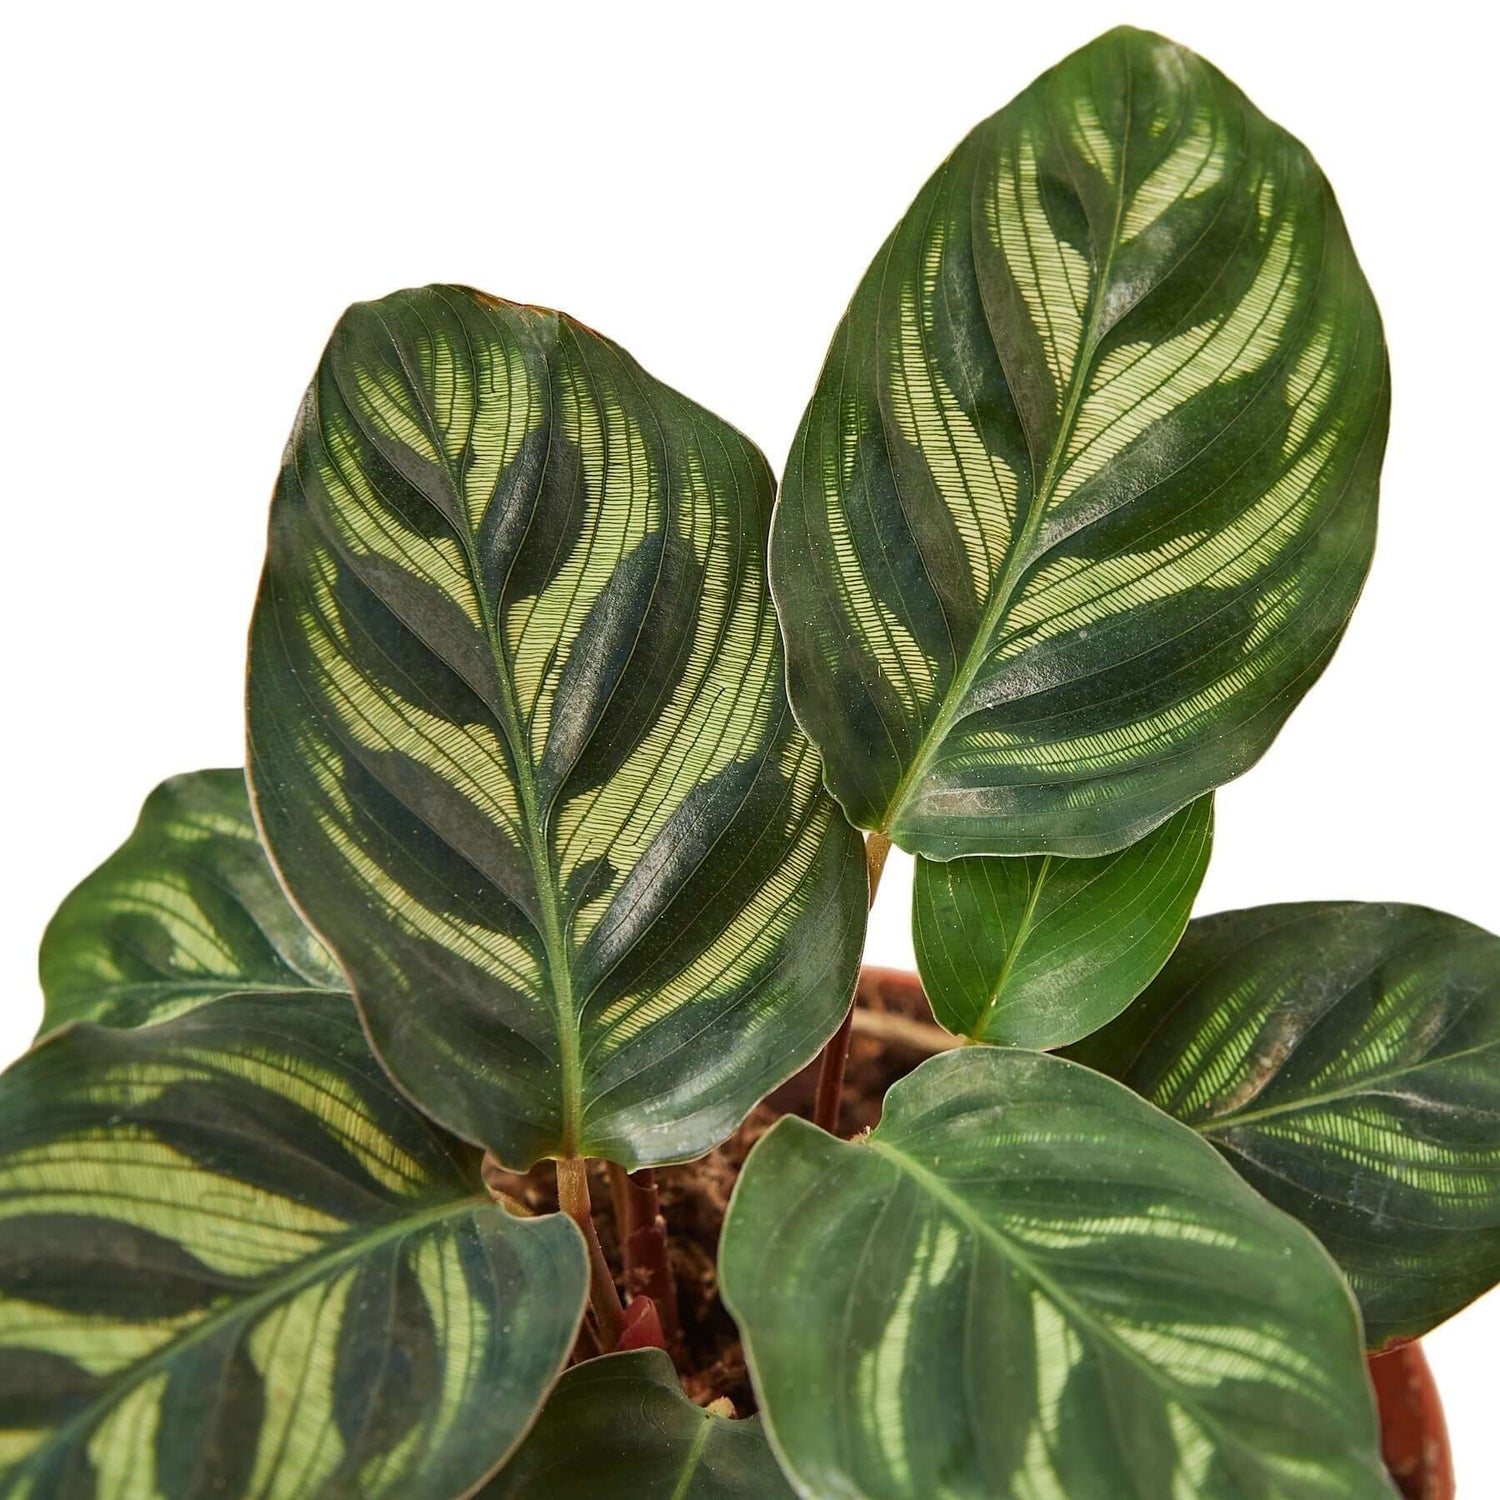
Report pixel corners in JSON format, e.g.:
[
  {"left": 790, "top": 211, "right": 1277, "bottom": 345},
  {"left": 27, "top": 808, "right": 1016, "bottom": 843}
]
[{"left": 1071, "top": 902, "right": 1500, "bottom": 1349}]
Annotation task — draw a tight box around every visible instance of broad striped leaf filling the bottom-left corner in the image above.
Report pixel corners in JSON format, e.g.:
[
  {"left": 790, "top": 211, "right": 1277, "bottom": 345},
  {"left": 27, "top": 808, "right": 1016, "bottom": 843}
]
[{"left": 0, "top": 995, "right": 588, "bottom": 1500}]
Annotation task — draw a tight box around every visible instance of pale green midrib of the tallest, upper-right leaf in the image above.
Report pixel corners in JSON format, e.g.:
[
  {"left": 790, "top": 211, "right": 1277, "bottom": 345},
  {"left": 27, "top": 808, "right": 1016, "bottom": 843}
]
[{"left": 879, "top": 87, "right": 1131, "bottom": 834}]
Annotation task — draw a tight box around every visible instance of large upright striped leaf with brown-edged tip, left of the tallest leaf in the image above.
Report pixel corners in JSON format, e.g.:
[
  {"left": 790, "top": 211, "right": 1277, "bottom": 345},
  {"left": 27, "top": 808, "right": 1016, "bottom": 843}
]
[{"left": 251, "top": 287, "right": 866, "bottom": 1169}]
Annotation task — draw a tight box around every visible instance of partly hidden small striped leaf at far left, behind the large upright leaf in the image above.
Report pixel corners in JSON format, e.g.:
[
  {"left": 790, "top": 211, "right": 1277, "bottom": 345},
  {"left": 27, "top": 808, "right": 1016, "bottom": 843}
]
[{"left": 42, "top": 770, "right": 348, "bottom": 1034}]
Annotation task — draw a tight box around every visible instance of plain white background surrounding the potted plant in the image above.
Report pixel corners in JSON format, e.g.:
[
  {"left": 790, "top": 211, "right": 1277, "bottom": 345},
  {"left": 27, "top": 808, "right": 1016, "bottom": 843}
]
[{"left": 0, "top": 0, "right": 1500, "bottom": 1500}]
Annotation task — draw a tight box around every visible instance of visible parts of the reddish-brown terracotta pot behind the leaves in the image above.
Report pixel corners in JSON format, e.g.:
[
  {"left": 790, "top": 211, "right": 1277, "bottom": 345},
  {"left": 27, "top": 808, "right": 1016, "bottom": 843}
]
[{"left": 855, "top": 966, "right": 1455, "bottom": 1500}]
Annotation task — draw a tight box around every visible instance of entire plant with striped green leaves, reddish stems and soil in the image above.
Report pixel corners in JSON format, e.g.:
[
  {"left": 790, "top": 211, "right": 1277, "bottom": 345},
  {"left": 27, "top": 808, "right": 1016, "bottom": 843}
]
[{"left": 0, "top": 23, "right": 1500, "bottom": 1500}]
